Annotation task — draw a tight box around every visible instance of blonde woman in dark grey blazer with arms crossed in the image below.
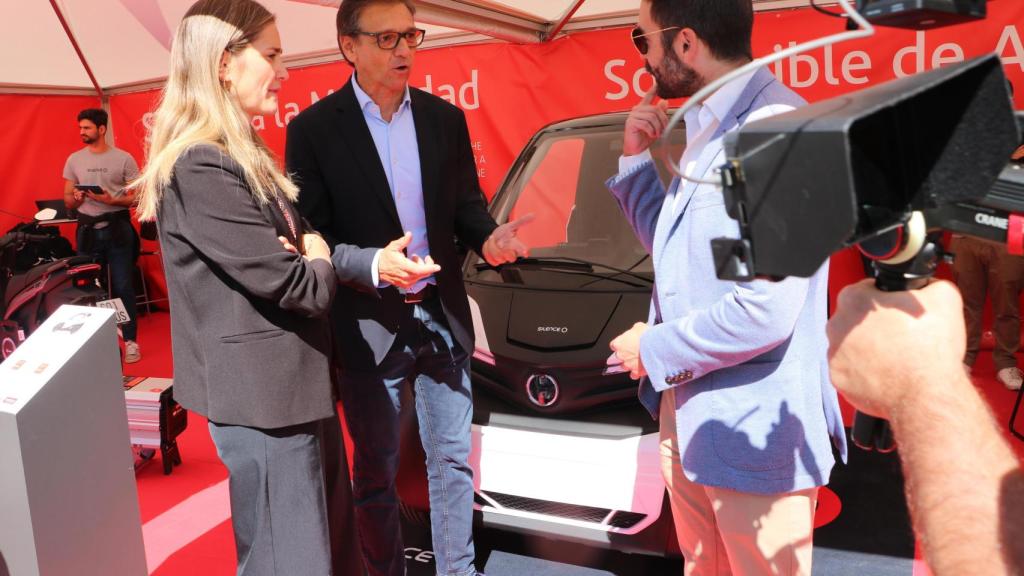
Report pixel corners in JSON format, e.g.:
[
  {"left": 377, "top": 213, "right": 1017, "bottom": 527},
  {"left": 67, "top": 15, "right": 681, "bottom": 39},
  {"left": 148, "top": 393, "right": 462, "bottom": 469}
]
[{"left": 136, "top": 0, "right": 361, "bottom": 575}]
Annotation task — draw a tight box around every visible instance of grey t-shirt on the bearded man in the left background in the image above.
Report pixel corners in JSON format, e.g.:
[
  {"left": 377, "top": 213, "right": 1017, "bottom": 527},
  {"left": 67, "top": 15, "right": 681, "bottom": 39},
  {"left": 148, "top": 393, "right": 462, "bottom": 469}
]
[{"left": 63, "top": 147, "right": 138, "bottom": 216}]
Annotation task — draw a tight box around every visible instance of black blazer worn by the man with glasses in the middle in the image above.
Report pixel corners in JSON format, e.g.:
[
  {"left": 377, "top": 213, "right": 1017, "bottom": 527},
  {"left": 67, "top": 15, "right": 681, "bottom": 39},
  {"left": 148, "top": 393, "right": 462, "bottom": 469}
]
[{"left": 285, "top": 77, "right": 497, "bottom": 370}]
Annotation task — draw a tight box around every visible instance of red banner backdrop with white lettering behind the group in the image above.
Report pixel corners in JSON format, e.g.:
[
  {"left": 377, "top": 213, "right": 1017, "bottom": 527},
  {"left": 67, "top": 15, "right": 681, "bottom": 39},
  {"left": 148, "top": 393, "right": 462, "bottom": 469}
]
[{"left": 6, "top": 0, "right": 1024, "bottom": 309}]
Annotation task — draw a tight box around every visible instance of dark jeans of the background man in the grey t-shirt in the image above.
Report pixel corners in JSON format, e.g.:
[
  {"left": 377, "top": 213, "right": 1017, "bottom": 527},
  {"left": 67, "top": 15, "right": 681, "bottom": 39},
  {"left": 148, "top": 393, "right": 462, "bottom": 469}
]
[{"left": 76, "top": 219, "right": 138, "bottom": 340}]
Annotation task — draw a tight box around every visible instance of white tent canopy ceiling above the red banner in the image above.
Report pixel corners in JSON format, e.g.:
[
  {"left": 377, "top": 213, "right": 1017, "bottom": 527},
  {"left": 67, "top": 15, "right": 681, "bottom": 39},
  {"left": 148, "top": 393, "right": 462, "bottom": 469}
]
[{"left": 0, "top": 0, "right": 815, "bottom": 94}]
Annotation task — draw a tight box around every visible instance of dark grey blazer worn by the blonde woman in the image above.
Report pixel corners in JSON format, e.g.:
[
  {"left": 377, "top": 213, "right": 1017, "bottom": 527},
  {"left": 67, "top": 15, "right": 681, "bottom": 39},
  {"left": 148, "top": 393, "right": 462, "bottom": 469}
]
[{"left": 157, "top": 145, "right": 337, "bottom": 428}]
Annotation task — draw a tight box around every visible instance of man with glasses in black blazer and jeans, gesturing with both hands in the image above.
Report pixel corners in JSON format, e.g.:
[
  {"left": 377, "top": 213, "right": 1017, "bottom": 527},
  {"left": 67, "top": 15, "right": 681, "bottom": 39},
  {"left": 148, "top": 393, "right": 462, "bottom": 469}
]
[{"left": 286, "top": 0, "right": 526, "bottom": 576}]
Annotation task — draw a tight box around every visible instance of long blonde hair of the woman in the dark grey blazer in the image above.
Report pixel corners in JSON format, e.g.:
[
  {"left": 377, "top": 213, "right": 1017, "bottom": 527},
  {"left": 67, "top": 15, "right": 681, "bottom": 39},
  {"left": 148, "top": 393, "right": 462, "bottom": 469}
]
[{"left": 133, "top": 0, "right": 299, "bottom": 220}]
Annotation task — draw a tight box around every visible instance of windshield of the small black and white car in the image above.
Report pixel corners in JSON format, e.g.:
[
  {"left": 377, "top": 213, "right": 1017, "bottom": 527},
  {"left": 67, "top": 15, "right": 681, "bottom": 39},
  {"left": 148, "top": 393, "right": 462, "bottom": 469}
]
[{"left": 477, "top": 123, "right": 685, "bottom": 286}]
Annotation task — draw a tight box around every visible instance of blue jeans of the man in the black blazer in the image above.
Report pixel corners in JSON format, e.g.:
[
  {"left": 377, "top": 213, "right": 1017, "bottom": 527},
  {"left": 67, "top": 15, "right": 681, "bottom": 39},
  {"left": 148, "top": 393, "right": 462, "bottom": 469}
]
[{"left": 340, "top": 298, "right": 476, "bottom": 576}]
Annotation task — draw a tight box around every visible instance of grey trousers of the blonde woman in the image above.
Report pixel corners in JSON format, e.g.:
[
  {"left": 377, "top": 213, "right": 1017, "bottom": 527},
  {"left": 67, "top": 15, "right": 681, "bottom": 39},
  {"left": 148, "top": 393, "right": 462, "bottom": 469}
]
[{"left": 210, "top": 417, "right": 362, "bottom": 576}]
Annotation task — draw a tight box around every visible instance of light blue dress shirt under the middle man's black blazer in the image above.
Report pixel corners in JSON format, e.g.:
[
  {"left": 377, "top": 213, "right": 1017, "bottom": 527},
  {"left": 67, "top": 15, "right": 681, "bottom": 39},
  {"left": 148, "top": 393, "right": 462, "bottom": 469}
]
[{"left": 352, "top": 75, "right": 434, "bottom": 292}]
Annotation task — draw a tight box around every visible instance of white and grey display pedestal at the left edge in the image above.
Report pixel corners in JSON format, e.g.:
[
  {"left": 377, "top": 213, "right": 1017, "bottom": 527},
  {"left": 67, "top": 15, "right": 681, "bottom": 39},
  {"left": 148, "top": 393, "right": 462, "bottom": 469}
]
[{"left": 0, "top": 305, "right": 146, "bottom": 576}]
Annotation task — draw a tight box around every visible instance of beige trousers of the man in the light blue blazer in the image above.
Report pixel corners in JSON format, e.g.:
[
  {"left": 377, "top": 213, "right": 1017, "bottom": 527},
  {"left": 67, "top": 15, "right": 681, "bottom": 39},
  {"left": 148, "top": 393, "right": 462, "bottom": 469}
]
[{"left": 660, "top": 389, "right": 818, "bottom": 576}]
